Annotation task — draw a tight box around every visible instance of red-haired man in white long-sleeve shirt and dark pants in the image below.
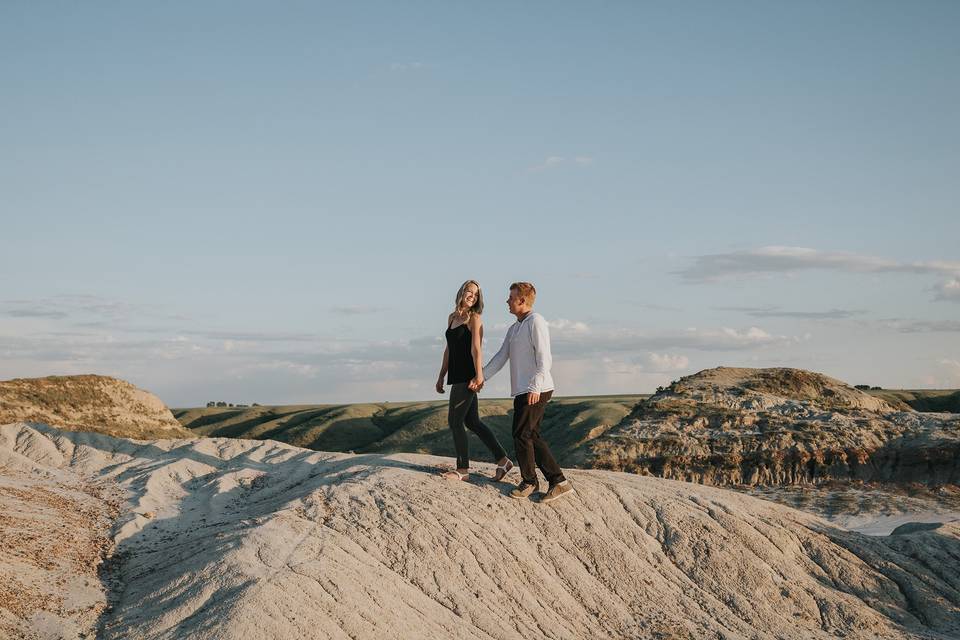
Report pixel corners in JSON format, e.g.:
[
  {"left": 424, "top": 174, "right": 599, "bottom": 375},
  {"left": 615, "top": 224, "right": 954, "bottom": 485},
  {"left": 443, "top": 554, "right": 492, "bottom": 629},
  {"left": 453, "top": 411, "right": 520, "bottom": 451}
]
[{"left": 472, "top": 282, "right": 573, "bottom": 502}]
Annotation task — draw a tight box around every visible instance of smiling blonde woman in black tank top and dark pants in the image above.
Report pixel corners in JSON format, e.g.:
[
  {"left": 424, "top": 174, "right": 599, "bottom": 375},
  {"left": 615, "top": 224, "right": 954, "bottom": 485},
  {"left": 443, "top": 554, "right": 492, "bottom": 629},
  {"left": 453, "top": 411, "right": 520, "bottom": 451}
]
[{"left": 437, "top": 280, "right": 513, "bottom": 481}]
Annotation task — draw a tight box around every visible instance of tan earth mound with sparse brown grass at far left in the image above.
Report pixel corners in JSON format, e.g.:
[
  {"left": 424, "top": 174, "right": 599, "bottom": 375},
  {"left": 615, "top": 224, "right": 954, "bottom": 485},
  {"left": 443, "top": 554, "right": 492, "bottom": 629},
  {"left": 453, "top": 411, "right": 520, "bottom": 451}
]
[{"left": 0, "top": 375, "right": 196, "bottom": 440}]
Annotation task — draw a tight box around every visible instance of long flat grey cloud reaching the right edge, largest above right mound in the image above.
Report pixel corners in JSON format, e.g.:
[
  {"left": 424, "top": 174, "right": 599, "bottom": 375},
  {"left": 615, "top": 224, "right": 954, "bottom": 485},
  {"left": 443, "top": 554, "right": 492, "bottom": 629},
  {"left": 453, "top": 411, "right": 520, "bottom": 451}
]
[{"left": 675, "top": 246, "right": 960, "bottom": 286}]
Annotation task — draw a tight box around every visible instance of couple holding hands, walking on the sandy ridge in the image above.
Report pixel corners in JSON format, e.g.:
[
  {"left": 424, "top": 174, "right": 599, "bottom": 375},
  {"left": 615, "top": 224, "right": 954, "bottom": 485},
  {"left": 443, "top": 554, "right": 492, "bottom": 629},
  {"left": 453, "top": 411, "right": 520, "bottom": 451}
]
[{"left": 437, "top": 280, "right": 573, "bottom": 502}]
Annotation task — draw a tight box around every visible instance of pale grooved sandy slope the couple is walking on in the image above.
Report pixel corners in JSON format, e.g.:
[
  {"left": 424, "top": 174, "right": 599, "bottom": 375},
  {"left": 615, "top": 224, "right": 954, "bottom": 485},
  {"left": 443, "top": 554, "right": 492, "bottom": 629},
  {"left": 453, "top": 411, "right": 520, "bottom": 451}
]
[{"left": 0, "top": 424, "right": 960, "bottom": 639}]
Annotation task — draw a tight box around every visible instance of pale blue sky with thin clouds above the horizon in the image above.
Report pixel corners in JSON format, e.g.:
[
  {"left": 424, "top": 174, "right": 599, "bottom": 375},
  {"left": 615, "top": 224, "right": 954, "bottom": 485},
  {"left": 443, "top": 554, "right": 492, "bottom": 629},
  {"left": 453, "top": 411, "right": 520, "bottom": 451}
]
[{"left": 0, "top": 1, "right": 960, "bottom": 406}]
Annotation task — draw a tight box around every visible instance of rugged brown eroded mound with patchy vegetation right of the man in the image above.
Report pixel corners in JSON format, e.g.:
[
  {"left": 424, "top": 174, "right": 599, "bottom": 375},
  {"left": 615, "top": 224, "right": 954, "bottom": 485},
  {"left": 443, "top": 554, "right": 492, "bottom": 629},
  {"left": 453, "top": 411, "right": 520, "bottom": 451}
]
[{"left": 588, "top": 367, "right": 960, "bottom": 486}]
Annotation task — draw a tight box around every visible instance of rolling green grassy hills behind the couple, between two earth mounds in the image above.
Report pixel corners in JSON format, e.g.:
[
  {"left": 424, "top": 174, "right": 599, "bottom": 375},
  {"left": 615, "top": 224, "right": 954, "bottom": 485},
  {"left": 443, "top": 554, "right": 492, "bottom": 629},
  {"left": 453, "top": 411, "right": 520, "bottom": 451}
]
[{"left": 173, "top": 395, "right": 648, "bottom": 466}]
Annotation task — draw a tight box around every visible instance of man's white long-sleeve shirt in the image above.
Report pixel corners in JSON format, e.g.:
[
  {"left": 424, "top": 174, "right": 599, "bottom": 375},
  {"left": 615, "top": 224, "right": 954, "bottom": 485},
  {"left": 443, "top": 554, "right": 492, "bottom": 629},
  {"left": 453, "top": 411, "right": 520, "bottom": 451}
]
[{"left": 483, "top": 312, "right": 553, "bottom": 397}]
